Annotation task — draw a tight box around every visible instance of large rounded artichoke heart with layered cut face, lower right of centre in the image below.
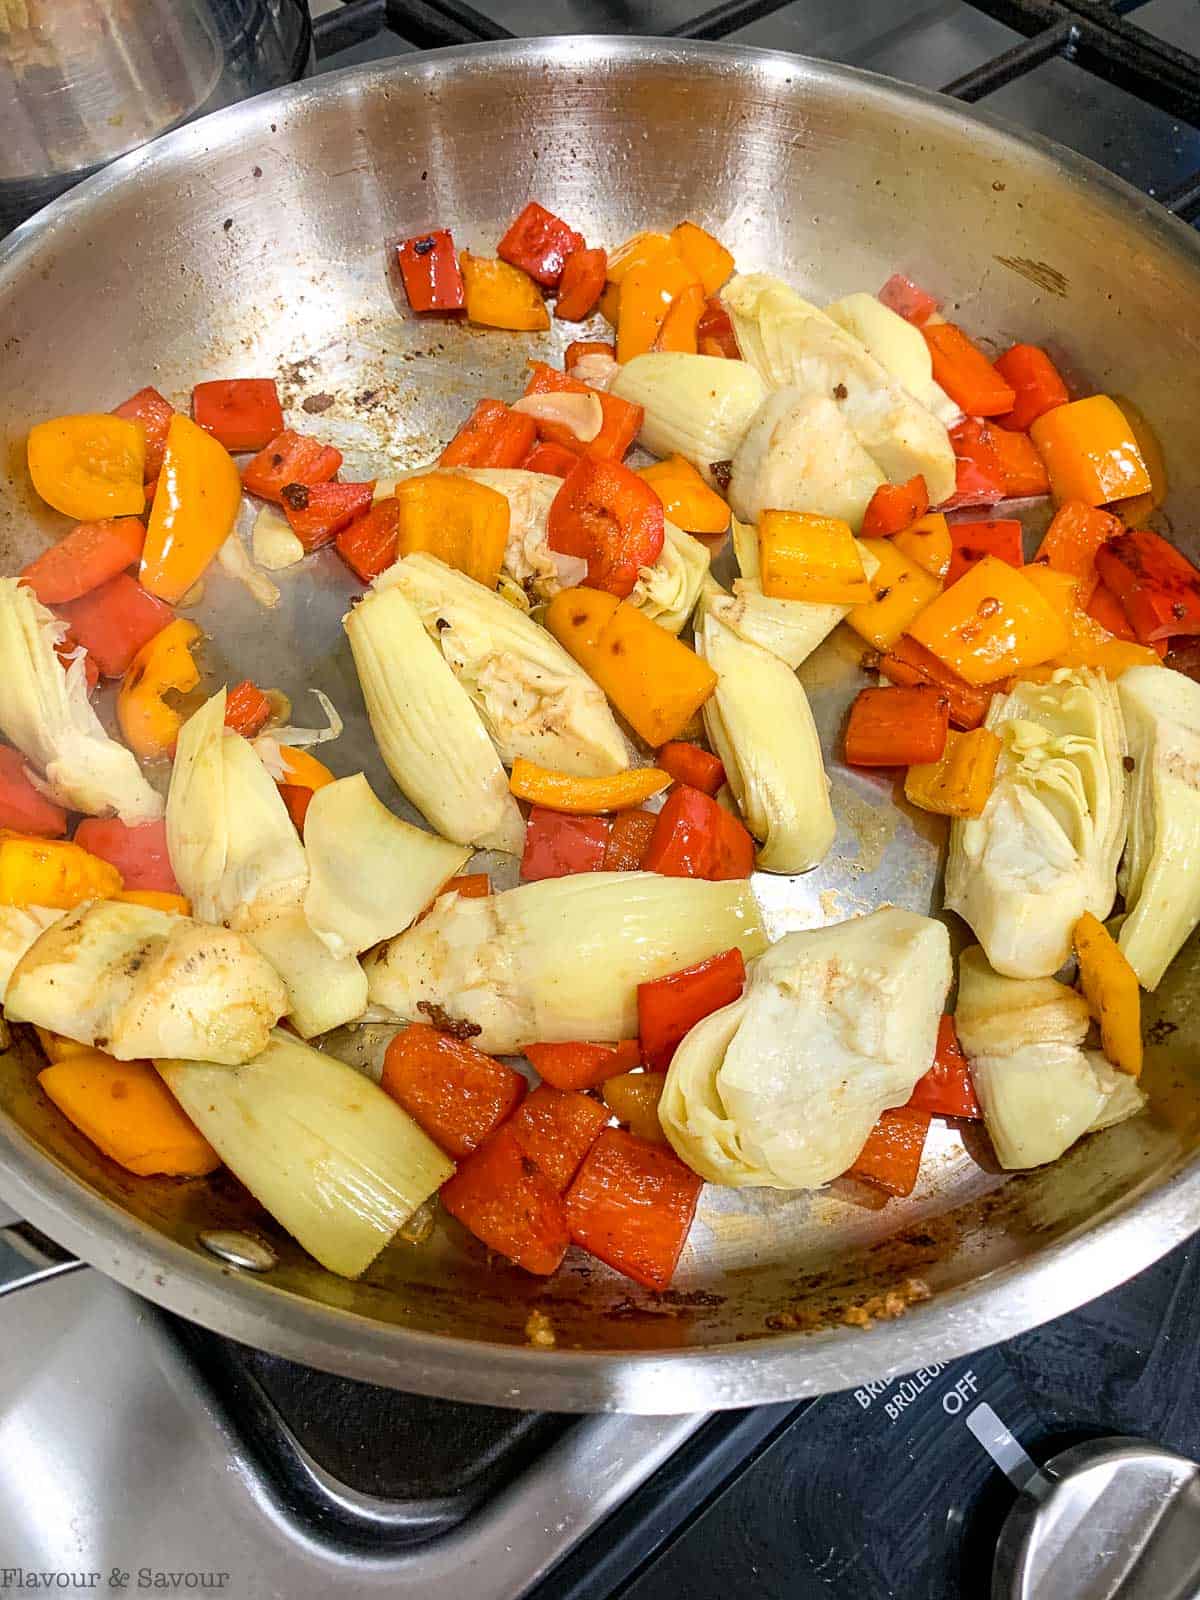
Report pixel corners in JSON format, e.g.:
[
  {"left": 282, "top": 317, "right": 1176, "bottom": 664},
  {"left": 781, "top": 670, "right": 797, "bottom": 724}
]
[{"left": 659, "top": 907, "right": 952, "bottom": 1189}]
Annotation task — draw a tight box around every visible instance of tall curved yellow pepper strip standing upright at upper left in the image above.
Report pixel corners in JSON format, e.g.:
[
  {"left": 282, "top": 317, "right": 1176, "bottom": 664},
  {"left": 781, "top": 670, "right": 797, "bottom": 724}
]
[{"left": 138, "top": 411, "right": 242, "bottom": 605}]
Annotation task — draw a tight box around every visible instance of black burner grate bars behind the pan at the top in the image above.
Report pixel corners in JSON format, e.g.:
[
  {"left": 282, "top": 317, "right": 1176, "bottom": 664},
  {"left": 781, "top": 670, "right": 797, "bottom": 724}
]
[{"left": 315, "top": 0, "right": 1200, "bottom": 221}]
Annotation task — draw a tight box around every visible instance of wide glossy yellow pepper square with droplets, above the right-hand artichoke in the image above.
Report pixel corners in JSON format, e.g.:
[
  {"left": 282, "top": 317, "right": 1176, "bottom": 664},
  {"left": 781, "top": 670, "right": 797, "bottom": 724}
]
[{"left": 909, "top": 555, "right": 1070, "bottom": 683}]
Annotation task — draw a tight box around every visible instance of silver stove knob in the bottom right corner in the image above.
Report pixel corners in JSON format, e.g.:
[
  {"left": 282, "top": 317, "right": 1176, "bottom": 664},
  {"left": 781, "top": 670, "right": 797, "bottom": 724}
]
[{"left": 992, "top": 1438, "right": 1200, "bottom": 1600}]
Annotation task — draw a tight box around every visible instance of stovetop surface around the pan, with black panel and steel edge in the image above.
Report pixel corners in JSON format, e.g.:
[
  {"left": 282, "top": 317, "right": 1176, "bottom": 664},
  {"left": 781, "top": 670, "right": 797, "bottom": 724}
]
[{"left": 0, "top": 0, "right": 1200, "bottom": 1600}]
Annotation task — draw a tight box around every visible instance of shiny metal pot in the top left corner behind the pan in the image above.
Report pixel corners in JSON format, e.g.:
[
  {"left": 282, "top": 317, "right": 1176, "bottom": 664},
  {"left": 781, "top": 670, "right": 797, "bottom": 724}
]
[{"left": 0, "top": 0, "right": 312, "bottom": 234}]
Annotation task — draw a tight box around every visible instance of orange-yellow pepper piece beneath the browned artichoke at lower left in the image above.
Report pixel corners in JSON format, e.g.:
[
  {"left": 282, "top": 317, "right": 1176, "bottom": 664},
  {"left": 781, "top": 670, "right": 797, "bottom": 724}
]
[{"left": 37, "top": 1050, "right": 221, "bottom": 1178}]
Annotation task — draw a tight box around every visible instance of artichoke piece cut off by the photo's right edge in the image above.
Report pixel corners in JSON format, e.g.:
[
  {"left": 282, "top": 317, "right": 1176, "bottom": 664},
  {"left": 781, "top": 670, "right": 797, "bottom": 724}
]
[{"left": 1117, "top": 667, "right": 1200, "bottom": 989}]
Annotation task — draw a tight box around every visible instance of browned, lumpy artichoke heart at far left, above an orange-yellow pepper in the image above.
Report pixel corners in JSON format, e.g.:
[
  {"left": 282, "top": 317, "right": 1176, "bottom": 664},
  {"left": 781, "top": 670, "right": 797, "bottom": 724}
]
[{"left": 5, "top": 901, "right": 288, "bottom": 1066}]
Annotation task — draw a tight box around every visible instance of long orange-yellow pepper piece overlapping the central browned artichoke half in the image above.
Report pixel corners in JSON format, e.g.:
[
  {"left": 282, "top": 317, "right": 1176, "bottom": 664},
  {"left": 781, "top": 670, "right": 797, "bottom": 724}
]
[{"left": 546, "top": 587, "right": 717, "bottom": 749}]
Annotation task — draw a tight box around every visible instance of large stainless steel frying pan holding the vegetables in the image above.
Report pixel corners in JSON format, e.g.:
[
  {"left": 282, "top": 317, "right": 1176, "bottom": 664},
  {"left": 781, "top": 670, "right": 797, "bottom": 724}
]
[{"left": 0, "top": 38, "right": 1200, "bottom": 1411}]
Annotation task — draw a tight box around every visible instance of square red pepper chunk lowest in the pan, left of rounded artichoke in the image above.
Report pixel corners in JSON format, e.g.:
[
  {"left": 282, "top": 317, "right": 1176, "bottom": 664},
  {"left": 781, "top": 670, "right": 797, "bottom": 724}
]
[{"left": 566, "top": 1128, "right": 704, "bottom": 1290}]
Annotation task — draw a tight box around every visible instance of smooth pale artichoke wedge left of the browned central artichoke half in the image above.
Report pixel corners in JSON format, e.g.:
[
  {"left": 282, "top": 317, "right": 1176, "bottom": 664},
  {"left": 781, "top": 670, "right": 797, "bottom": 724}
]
[{"left": 344, "top": 574, "right": 525, "bottom": 854}]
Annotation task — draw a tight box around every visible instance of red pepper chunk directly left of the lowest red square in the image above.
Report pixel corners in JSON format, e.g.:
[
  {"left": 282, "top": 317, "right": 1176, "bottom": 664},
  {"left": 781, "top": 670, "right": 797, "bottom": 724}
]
[{"left": 442, "top": 1128, "right": 571, "bottom": 1277}]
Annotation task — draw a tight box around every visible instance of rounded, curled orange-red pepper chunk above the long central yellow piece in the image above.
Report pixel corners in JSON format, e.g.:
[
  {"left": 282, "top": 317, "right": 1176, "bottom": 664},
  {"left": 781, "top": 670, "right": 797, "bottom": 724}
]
[{"left": 546, "top": 456, "right": 666, "bottom": 600}]
